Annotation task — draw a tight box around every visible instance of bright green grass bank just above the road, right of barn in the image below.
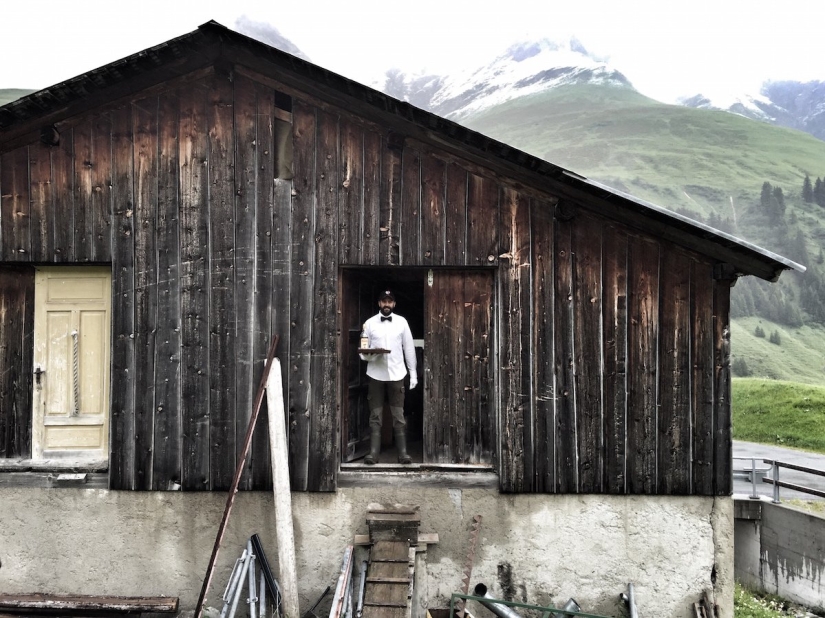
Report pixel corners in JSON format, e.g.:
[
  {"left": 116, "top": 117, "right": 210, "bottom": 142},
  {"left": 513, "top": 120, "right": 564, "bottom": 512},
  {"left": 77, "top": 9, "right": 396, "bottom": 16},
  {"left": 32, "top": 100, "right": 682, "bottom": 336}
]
[{"left": 732, "top": 378, "right": 825, "bottom": 453}]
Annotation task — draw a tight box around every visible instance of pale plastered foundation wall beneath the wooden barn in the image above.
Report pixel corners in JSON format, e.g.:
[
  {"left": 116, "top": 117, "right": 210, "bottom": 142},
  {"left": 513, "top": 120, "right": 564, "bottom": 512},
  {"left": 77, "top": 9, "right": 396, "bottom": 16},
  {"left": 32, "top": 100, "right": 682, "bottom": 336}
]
[{"left": 0, "top": 487, "right": 733, "bottom": 618}]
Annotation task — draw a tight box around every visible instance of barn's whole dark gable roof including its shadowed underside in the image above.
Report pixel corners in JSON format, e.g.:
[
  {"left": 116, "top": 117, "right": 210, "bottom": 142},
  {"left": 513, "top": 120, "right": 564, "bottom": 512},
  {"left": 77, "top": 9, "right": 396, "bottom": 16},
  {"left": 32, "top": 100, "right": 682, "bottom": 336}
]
[{"left": 0, "top": 21, "right": 805, "bottom": 281}]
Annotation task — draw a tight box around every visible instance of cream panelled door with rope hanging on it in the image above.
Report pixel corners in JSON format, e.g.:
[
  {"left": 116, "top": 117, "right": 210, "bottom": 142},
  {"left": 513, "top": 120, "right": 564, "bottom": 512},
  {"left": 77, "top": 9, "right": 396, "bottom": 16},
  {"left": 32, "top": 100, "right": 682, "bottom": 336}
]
[{"left": 32, "top": 267, "right": 112, "bottom": 459}]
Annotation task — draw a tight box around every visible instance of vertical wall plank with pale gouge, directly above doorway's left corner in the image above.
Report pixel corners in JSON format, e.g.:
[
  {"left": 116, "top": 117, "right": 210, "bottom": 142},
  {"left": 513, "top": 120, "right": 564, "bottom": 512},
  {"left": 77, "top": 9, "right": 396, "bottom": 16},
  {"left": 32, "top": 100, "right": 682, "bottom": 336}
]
[{"left": 334, "top": 118, "right": 364, "bottom": 264}]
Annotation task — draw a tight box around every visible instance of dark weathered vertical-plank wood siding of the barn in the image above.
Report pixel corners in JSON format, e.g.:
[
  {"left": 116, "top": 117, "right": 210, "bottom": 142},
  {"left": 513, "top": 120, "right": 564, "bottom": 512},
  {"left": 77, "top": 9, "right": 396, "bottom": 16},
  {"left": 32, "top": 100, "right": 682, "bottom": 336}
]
[{"left": 0, "top": 68, "right": 730, "bottom": 495}]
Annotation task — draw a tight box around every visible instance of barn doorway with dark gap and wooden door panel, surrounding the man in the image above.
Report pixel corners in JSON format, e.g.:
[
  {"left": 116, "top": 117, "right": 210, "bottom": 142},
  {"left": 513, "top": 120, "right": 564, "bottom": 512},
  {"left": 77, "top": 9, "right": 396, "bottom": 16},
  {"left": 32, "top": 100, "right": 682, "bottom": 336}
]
[{"left": 340, "top": 267, "right": 496, "bottom": 466}]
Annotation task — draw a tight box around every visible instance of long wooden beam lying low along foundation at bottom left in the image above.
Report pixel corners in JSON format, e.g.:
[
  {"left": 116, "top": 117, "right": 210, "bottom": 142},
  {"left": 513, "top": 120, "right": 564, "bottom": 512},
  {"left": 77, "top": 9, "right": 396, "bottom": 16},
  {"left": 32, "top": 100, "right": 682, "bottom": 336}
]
[{"left": 0, "top": 593, "right": 178, "bottom": 614}]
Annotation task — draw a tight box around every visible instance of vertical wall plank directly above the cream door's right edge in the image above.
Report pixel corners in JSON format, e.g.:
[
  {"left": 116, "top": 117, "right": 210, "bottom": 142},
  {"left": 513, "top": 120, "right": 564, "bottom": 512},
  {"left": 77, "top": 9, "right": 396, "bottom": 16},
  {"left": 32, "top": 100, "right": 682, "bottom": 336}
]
[{"left": 91, "top": 113, "right": 112, "bottom": 262}]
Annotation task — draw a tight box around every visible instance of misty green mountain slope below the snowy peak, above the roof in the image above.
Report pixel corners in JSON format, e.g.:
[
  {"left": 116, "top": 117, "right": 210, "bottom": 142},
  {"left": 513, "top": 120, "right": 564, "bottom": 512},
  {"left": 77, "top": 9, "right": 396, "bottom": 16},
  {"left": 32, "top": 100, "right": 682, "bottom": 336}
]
[{"left": 462, "top": 85, "right": 825, "bottom": 220}]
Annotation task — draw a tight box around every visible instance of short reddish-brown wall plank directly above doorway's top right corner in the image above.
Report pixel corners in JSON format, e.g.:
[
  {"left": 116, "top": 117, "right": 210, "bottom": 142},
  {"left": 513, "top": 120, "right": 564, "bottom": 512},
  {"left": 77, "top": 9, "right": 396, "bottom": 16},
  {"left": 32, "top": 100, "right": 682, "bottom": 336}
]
[{"left": 466, "top": 174, "right": 498, "bottom": 266}]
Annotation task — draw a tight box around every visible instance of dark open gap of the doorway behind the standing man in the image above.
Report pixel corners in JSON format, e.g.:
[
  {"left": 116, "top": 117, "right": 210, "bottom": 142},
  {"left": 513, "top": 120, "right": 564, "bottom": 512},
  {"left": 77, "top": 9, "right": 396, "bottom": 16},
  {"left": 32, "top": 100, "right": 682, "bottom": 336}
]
[{"left": 341, "top": 267, "right": 428, "bottom": 463}]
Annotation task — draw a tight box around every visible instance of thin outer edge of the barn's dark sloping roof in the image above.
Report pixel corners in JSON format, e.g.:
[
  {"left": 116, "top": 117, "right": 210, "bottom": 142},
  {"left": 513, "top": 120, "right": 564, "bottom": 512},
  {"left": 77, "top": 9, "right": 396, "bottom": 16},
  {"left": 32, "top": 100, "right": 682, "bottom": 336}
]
[{"left": 0, "top": 20, "right": 806, "bottom": 280}]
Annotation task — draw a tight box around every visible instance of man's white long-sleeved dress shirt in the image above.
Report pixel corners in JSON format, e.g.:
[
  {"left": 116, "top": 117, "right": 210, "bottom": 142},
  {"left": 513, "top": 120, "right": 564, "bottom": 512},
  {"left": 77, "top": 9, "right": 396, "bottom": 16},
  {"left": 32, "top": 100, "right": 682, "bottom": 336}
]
[{"left": 361, "top": 313, "right": 418, "bottom": 382}]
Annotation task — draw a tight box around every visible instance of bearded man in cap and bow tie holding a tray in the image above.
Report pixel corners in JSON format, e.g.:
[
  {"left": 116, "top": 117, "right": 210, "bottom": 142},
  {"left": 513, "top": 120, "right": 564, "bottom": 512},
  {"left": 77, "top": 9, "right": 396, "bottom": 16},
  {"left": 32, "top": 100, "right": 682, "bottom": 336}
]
[{"left": 361, "top": 290, "right": 418, "bottom": 465}]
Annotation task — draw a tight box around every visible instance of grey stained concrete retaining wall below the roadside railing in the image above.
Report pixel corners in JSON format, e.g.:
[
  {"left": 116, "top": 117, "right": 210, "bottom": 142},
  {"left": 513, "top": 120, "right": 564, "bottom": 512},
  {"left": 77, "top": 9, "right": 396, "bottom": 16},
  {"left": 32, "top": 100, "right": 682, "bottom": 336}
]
[{"left": 735, "top": 502, "right": 825, "bottom": 609}]
